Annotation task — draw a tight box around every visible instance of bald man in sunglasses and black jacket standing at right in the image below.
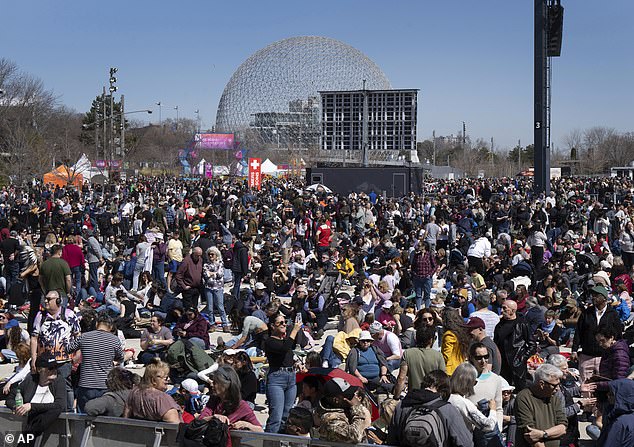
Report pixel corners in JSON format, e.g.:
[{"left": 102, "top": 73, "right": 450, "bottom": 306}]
[{"left": 493, "top": 300, "right": 537, "bottom": 391}]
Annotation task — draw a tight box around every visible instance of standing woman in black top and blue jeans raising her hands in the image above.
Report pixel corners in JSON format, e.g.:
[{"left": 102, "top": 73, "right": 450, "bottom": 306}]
[{"left": 264, "top": 314, "right": 302, "bottom": 433}]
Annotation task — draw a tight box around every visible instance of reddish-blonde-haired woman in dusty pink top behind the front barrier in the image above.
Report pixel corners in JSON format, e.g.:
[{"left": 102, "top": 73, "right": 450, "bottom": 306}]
[{"left": 123, "top": 358, "right": 183, "bottom": 424}]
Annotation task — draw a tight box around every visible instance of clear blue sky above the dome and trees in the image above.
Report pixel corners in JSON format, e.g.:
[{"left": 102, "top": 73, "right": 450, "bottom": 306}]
[{"left": 0, "top": 0, "right": 634, "bottom": 149}]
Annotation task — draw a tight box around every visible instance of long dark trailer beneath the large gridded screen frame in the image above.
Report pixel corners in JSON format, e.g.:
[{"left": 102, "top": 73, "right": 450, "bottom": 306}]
[{"left": 306, "top": 166, "right": 425, "bottom": 197}]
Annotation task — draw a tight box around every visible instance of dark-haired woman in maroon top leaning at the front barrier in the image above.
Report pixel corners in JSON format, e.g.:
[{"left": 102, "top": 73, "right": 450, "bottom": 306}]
[{"left": 198, "top": 365, "right": 264, "bottom": 432}]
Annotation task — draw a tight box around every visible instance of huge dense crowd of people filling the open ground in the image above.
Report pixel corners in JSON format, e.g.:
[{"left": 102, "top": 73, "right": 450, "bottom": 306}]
[{"left": 0, "top": 176, "right": 634, "bottom": 447}]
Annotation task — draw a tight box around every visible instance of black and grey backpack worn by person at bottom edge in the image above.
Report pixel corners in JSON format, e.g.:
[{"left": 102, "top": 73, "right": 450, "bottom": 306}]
[{"left": 400, "top": 399, "right": 448, "bottom": 447}]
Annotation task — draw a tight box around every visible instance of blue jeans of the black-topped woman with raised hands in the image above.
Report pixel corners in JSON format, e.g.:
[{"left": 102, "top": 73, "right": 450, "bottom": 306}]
[{"left": 264, "top": 370, "right": 297, "bottom": 433}]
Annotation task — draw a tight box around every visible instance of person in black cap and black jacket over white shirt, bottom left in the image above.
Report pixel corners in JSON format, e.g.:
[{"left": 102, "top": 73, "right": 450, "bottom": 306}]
[{"left": 6, "top": 352, "right": 66, "bottom": 444}]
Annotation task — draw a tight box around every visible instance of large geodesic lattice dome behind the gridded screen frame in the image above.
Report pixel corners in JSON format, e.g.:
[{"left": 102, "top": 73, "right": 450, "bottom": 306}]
[{"left": 216, "top": 36, "right": 391, "bottom": 149}]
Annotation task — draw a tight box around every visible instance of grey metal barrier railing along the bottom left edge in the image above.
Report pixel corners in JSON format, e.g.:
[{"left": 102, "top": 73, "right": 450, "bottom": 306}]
[{"left": 0, "top": 408, "right": 386, "bottom": 447}]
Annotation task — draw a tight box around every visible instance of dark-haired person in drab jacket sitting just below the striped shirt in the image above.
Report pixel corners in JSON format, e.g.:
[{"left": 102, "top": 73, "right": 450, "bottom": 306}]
[{"left": 84, "top": 367, "right": 141, "bottom": 417}]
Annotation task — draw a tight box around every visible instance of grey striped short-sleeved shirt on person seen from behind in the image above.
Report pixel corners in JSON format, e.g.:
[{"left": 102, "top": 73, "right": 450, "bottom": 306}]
[{"left": 69, "top": 330, "right": 123, "bottom": 390}]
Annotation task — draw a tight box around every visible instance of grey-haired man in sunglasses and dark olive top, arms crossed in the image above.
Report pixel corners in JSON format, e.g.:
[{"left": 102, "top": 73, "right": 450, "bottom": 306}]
[{"left": 515, "top": 363, "right": 568, "bottom": 447}]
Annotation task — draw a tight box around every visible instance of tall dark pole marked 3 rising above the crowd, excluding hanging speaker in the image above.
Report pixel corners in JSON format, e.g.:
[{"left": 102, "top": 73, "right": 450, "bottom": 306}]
[{"left": 533, "top": 0, "right": 550, "bottom": 195}]
